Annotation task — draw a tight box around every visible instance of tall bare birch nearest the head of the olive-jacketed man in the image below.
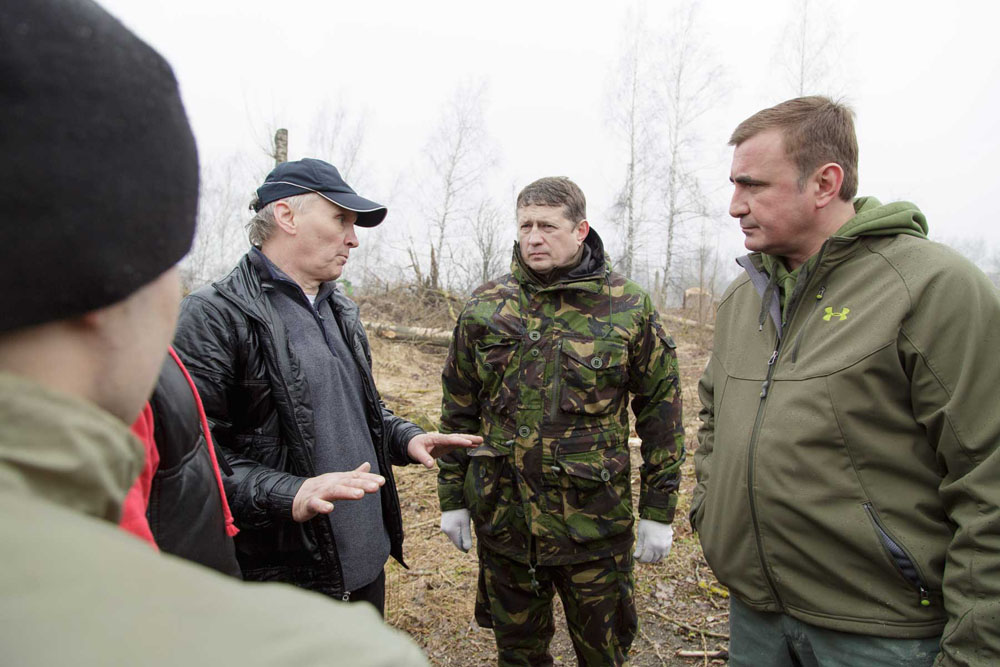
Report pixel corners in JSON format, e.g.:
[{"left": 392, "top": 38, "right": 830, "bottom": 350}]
[{"left": 656, "top": 2, "right": 721, "bottom": 304}]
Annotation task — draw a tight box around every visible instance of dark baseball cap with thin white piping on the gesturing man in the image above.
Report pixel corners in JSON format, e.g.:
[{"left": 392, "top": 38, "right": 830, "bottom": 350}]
[{"left": 251, "top": 158, "right": 389, "bottom": 227}]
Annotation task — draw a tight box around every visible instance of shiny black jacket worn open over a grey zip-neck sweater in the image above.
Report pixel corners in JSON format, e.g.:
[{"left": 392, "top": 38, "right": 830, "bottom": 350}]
[{"left": 174, "top": 252, "right": 423, "bottom": 595}]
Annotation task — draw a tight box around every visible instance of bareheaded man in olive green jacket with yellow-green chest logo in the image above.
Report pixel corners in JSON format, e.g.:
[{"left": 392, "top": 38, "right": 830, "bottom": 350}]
[{"left": 691, "top": 97, "right": 1000, "bottom": 665}]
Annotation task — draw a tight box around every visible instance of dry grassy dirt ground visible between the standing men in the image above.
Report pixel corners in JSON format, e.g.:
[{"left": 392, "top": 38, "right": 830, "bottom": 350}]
[{"left": 359, "top": 299, "right": 728, "bottom": 667}]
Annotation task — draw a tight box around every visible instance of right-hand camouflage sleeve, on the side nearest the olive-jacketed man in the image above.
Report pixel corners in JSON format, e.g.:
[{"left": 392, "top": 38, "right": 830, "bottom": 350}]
[{"left": 629, "top": 296, "right": 684, "bottom": 523}]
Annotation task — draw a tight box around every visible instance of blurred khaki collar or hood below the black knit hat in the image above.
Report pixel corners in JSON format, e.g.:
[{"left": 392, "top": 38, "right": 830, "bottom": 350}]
[{"left": 0, "top": 373, "right": 144, "bottom": 523}]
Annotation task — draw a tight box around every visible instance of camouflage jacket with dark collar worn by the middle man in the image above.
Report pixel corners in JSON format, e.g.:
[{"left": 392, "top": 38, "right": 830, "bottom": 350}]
[{"left": 438, "top": 230, "right": 684, "bottom": 565}]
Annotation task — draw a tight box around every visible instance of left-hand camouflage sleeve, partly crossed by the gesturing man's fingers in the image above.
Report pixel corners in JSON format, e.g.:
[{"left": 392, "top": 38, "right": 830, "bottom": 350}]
[{"left": 437, "top": 317, "right": 480, "bottom": 512}]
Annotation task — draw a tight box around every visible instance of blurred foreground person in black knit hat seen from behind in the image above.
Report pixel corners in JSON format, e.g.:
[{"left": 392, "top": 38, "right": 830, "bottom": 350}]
[{"left": 0, "top": 0, "right": 425, "bottom": 667}]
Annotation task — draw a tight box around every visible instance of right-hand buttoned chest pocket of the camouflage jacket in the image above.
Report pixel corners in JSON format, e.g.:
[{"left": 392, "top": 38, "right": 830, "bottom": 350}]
[{"left": 556, "top": 338, "right": 628, "bottom": 415}]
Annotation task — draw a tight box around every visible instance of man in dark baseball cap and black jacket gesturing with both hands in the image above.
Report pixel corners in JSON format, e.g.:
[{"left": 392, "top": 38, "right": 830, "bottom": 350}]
[{"left": 174, "top": 158, "right": 482, "bottom": 611}]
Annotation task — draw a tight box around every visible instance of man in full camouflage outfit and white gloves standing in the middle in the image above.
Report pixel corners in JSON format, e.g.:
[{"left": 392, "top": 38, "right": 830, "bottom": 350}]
[{"left": 438, "top": 178, "right": 684, "bottom": 665}]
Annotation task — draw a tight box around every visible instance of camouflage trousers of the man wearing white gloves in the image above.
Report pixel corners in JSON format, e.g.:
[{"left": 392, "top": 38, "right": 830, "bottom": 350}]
[{"left": 476, "top": 549, "right": 639, "bottom": 666}]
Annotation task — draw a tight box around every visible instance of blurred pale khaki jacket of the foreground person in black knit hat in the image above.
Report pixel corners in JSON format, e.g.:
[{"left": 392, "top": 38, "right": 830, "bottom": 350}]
[{"left": 0, "top": 373, "right": 426, "bottom": 667}]
